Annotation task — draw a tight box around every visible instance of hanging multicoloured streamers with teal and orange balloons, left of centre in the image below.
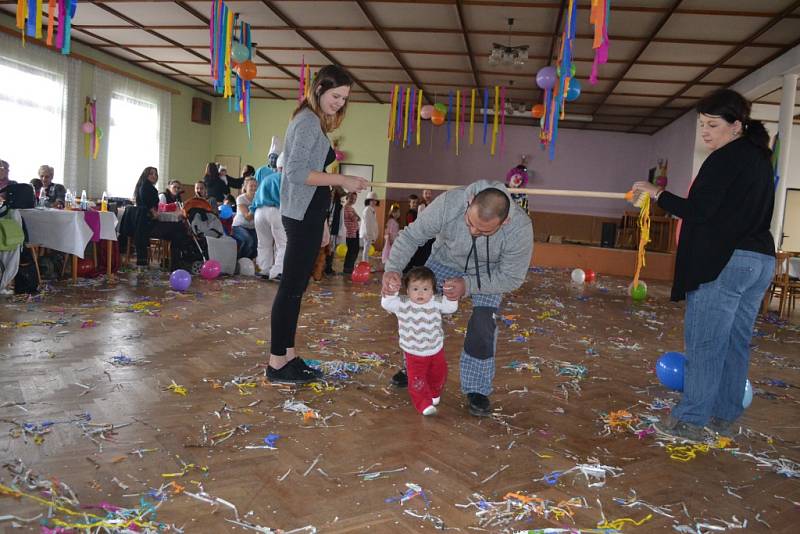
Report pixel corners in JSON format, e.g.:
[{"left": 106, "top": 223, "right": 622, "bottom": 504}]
[{"left": 208, "top": 0, "right": 257, "bottom": 139}]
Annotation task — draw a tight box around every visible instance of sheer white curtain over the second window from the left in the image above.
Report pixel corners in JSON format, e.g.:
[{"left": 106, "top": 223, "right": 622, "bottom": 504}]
[{"left": 88, "top": 67, "right": 172, "bottom": 197}]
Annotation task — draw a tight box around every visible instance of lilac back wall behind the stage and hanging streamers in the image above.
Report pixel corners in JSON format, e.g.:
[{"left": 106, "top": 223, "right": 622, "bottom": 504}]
[{"left": 382, "top": 122, "right": 655, "bottom": 216}]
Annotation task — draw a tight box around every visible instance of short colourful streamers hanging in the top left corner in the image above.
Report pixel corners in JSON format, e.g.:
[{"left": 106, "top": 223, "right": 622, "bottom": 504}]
[{"left": 17, "top": 0, "right": 78, "bottom": 55}]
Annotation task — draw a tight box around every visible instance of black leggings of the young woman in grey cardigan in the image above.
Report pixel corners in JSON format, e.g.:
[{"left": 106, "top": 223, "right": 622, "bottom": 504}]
[{"left": 270, "top": 186, "right": 331, "bottom": 356}]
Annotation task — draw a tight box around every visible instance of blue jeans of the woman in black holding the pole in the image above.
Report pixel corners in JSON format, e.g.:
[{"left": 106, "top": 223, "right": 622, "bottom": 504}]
[{"left": 672, "top": 250, "right": 775, "bottom": 426}]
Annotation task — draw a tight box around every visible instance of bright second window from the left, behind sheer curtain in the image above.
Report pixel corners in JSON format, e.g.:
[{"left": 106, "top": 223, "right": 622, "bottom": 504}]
[{"left": 107, "top": 92, "right": 160, "bottom": 198}]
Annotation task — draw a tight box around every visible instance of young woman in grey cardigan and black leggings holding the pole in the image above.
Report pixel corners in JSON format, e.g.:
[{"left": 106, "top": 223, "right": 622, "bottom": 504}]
[{"left": 267, "top": 65, "right": 369, "bottom": 384}]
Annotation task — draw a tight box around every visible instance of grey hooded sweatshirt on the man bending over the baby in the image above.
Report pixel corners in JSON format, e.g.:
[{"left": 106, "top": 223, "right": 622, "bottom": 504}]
[{"left": 386, "top": 180, "right": 533, "bottom": 295}]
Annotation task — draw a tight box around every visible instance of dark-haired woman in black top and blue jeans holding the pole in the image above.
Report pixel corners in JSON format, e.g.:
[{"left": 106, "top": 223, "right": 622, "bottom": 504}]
[{"left": 633, "top": 89, "right": 775, "bottom": 441}]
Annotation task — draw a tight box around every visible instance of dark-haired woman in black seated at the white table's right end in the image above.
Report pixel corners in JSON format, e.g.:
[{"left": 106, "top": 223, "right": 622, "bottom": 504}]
[{"left": 134, "top": 167, "right": 189, "bottom": 270}]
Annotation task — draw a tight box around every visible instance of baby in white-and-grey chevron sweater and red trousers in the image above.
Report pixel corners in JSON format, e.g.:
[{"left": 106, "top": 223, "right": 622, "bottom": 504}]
[{"left": 381, "top": 267, "right": 458, "bottom": 415}]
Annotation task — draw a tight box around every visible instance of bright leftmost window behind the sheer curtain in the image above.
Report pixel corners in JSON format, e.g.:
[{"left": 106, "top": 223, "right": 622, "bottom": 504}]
[{"left": 0, "top": 57, "right": 67, "bottom": 182}]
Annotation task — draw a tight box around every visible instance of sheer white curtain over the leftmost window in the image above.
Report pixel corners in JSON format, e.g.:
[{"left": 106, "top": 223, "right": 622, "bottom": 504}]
[{"left": 0, "top": 34, "right": 82, "bottom": 189}]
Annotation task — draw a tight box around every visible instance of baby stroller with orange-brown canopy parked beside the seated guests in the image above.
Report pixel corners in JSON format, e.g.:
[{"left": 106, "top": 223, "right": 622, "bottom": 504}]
[{"left": 183, "top": 197, "right": 236, "bottom": 274}]
